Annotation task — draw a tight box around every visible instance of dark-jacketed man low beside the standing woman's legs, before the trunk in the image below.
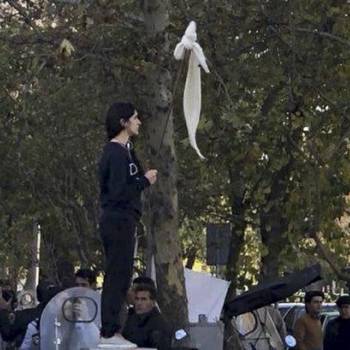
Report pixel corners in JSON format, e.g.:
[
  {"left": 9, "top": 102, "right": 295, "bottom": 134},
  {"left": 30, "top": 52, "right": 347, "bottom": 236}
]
[{"left": 123, "top": 284, "right": 171, "bottom": 350}]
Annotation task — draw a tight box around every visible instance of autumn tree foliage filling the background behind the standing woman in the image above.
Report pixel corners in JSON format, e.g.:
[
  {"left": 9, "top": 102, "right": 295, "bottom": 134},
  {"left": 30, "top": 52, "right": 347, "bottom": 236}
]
[{"left": 0, "top": 0, "right": 350, "bottom": 292}]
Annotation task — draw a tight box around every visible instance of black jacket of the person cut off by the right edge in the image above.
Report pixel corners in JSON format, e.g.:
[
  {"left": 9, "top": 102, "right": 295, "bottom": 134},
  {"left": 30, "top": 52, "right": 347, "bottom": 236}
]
[{"left": 323, "top": 317, "right": 350, "bottom": 350}]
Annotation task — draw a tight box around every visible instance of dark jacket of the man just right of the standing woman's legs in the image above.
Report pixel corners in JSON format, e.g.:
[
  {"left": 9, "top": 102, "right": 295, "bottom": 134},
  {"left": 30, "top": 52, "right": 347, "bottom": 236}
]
[{"left": 123, "top": 307, "right": 171, "bottom": 350}]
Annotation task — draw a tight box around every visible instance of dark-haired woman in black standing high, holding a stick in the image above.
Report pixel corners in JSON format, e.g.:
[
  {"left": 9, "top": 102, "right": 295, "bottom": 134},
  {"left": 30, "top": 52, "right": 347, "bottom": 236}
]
[{"left": 99, "top": 102, "right": 157, "bottom": 348}]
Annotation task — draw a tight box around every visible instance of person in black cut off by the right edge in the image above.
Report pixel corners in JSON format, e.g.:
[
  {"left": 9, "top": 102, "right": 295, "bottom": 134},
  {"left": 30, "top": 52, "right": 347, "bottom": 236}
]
[{"left": 324, "top": 295, "right": 350, "bottom": 350}]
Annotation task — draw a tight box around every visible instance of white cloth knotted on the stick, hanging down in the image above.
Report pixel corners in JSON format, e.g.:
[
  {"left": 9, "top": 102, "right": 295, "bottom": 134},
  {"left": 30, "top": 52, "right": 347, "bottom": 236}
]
[{"left": 174, "top": 21, "right": 209, "bottom": 159}]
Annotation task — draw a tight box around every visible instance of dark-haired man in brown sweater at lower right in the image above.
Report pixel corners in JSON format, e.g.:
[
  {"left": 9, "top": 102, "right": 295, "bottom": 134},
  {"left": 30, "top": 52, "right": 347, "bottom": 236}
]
[{"left": 294, "top": 291, "right": 324, "bottom": 350}]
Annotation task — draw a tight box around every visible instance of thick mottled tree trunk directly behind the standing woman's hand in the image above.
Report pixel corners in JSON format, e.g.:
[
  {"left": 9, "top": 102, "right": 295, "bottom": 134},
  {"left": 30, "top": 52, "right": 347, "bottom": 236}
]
[{"left": 143, "top": 0, "right": 188, "bottom": 328}]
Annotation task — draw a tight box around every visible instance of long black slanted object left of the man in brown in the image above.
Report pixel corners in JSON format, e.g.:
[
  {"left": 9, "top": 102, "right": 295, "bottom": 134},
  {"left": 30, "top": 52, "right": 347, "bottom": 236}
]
[{"left": 224, "top": 264, "right": 321, "bottom": 317}]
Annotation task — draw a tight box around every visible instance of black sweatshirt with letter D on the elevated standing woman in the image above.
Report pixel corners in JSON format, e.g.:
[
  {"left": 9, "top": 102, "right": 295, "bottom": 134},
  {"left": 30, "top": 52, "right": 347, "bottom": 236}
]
[{"left": 99, "top": 142, "right": 150, "bottom": 218}]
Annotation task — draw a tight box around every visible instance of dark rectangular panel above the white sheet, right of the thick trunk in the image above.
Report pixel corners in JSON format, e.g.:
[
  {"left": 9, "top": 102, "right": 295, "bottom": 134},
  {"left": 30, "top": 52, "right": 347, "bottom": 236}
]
[{"left": 207, "top": 224, "right": 231, "bottom": 266}]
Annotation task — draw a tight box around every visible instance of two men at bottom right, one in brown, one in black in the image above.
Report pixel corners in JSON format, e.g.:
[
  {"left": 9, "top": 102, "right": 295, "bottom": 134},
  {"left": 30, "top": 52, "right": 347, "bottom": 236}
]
[{"left": 294, "top": 291, "right": 350, "bottom": 350}]
